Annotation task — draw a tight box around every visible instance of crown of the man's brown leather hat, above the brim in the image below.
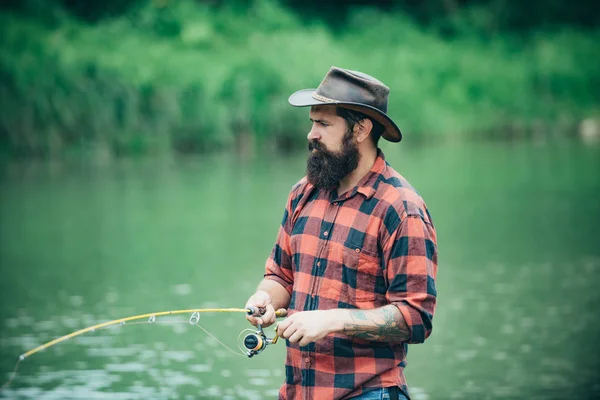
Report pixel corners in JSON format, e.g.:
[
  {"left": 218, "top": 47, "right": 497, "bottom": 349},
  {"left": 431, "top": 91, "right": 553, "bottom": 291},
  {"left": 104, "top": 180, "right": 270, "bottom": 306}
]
[{"left": 313, "top": 67, "right": 390, "bottom": 113}]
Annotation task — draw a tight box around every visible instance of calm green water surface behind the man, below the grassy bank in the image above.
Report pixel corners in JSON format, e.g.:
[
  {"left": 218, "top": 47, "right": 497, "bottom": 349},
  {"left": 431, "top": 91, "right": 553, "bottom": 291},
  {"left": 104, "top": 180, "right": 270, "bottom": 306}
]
[{"left": 0, "top": 142, "right": 600, "bottom": 400}]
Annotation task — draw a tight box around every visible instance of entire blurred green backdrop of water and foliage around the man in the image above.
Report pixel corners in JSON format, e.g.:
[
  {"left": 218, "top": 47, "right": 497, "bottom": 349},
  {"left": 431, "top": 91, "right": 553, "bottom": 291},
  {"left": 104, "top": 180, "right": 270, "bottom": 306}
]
[{"left": 0, "top": 0, "right": 600, "bottom": 399}]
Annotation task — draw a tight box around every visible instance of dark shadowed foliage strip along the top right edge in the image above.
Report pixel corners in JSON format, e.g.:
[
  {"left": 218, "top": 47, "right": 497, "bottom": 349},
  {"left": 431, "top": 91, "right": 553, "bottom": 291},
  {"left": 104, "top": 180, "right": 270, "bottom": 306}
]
[{"left": 280, "top": 0, "right": 600, "bottom": 32}]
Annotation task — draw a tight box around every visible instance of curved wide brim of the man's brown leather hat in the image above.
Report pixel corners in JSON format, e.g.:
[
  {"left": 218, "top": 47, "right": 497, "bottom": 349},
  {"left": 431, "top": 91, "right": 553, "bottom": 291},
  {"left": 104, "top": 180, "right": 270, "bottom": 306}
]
[{"left": 288, "top": 89, "right": 402, "bottom": 142}]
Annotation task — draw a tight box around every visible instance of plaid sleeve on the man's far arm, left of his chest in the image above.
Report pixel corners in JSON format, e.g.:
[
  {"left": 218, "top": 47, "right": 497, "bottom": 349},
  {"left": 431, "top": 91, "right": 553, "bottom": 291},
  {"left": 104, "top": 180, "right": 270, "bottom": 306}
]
[{"left": 265, "top": 191, "right": 294, "bottom": 296}]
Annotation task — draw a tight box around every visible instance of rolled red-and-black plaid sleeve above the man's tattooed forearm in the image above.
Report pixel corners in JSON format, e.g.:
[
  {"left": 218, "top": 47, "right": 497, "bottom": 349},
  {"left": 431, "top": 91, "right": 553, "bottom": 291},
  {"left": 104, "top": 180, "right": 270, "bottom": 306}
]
[{"left": 383, "top": 215, "right": 437, "bottom": 343}]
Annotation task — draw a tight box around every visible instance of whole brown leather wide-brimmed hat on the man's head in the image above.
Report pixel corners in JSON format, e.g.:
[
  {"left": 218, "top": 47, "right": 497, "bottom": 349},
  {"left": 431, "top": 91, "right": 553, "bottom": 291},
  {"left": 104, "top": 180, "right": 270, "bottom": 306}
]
[{"left": 288, "top": 67, "right": 402, "bottom": 142}]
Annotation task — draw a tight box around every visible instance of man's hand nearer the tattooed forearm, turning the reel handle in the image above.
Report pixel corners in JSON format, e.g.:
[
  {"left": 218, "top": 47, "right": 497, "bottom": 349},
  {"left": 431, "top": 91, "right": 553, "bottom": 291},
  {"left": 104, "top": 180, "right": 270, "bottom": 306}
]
[{"left": 277, "top": 310, "right": 335, "bottom": 346}]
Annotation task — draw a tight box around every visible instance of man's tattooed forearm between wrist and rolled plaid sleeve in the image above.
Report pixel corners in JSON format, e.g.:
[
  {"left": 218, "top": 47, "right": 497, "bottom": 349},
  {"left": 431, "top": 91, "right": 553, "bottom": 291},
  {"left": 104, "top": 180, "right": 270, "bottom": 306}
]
[{"left": 344, "top": 305, "right": 410, "bottom": 342}]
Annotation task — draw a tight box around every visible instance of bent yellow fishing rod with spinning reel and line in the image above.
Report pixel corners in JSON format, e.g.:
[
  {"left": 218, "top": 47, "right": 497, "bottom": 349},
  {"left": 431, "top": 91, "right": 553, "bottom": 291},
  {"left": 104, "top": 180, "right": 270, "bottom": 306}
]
[{"left": 0, "top": 307, "right": 287, "bottom": 389}]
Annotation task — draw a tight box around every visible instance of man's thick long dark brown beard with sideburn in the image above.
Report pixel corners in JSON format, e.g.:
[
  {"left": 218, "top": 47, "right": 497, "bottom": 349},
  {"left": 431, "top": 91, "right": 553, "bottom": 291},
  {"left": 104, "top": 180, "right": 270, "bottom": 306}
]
[{"left": 306, "top": 130, "right": 360, "bottom": 190}]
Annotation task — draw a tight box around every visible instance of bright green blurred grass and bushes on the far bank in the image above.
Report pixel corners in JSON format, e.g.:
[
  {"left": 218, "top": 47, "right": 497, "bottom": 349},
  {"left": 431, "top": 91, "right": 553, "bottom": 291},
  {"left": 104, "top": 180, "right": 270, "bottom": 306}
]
[{"left": 0, "top": 0, "right": 600, "bottom": 156}]
